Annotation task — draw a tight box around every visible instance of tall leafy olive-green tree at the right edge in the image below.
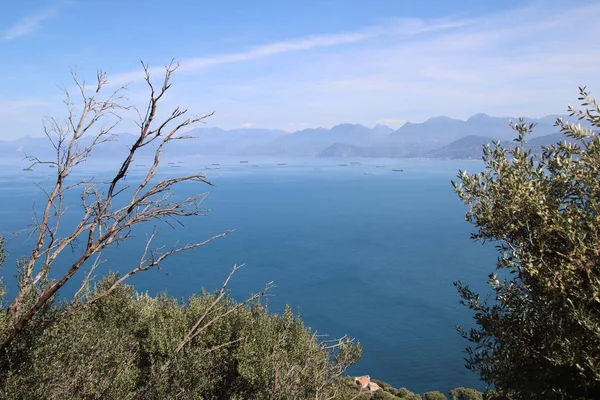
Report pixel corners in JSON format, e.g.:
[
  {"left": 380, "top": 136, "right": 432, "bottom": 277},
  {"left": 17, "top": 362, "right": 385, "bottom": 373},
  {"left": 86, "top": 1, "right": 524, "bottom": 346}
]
[{"left": 453, "top": 88, "right": 600, "bottom": 399}]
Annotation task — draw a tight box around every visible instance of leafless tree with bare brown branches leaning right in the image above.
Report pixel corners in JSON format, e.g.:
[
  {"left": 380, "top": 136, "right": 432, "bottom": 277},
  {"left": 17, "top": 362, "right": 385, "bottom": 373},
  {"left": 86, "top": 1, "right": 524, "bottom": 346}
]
[{"left": 0, "top": 63, "right": 246, "bottom": 352}]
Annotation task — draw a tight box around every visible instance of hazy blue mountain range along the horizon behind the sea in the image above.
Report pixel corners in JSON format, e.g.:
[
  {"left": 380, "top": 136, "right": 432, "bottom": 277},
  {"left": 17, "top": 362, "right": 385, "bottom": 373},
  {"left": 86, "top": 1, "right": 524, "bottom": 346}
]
[{"left": 0, "top": 114, "right": 580, "bottom": 159}]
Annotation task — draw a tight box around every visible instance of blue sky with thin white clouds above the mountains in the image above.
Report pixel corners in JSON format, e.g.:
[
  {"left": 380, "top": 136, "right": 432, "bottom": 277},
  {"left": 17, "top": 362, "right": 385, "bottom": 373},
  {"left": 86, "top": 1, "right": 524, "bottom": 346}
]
[{"left": 0, "top": 0, "right": 600, "bottom": 140}]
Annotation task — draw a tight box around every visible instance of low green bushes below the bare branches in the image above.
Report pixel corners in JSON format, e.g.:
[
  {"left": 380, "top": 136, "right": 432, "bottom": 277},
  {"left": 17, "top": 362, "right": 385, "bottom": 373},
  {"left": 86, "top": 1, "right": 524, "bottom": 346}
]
[{"left": 0, "top": 275, "right": 361, "bottom": 400}]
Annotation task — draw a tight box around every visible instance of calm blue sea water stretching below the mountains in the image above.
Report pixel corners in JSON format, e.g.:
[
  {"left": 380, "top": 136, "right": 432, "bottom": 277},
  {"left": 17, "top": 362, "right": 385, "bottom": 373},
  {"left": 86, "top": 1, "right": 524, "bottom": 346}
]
[{"left": 0, "top": 158, "right": 496, "bottom": 392}]
